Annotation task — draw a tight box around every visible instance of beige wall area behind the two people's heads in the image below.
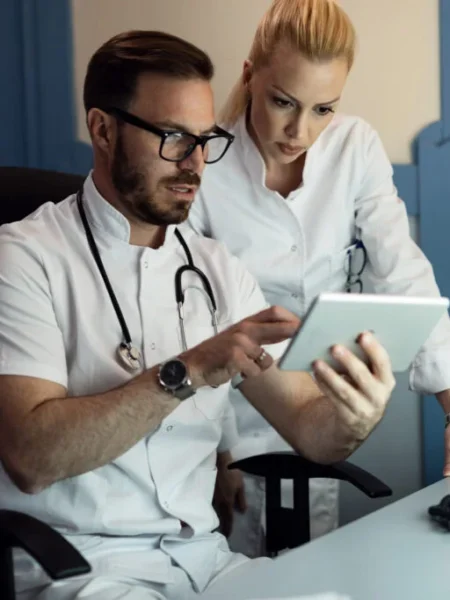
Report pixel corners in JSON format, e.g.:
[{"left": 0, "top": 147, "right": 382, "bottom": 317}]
[{"left": 72, "top": 0, "right": 439, "bottom": 162}]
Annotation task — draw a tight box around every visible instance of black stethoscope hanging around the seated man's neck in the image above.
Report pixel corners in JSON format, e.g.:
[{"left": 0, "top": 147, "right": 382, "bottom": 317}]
[{"left": 77, "top": 190, "right": 218, "bottom": 371}]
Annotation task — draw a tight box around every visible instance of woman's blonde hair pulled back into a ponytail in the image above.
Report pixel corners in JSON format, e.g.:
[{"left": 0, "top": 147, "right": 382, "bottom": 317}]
[{"left": 220, "top": 0, "right": 356, "bottom": 126}]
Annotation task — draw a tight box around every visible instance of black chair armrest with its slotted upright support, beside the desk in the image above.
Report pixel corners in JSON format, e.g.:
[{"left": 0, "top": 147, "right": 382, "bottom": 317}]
[{"left": 232, "top": 452, "right": 392, "bottom": 558}]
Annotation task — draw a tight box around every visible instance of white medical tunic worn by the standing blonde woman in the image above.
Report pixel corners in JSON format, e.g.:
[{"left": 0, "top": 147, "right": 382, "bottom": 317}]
[{"left": 189, "top": 115, "right": 450, "bottom": 536}]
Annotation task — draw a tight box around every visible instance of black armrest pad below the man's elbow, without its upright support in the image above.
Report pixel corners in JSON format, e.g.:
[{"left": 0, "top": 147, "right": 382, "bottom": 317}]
[{"left": 228, "top": 452, "right": 392, "bottom": 498}]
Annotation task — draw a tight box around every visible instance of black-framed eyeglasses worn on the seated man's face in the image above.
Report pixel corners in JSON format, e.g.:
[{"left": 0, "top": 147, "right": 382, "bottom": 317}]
[{"left": 103, "top": 107, "right": 234, "bottom": 164}]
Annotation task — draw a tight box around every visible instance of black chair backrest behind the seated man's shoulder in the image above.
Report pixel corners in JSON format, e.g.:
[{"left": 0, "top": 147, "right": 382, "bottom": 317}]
[{"left": 0, "top": 167, "right": 85, "bottom": 225}]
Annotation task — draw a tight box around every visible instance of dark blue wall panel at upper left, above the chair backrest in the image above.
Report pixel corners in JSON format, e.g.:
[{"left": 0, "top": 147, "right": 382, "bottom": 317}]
[{"left": 0, "top": 0, "right": 92, "bottom": 173}]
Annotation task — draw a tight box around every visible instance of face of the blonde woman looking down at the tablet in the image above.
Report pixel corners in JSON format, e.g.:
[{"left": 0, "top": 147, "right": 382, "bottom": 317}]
[{"left": 244, "top": 44, "right": 348, "bottom": 166}]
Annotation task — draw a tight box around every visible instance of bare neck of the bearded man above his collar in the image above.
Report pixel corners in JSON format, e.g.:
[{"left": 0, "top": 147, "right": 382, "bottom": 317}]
[{"left": 92, "top": 169, "right": 167, "bottom": 250}]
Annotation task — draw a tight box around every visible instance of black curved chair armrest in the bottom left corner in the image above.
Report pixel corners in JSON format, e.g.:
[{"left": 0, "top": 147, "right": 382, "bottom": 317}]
[{"left": 0, "top": 510, "right": 91, "bottom": 579}]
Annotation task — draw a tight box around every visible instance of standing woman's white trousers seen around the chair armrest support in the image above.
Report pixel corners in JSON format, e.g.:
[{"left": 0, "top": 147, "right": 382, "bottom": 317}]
[{"left": 228, "top": 473, "right": 339, "bottom": 558}]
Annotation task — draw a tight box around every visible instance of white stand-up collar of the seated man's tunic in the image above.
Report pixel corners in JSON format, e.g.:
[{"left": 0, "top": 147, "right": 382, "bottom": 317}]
[{"left": 83, "top": 171, "right": 176, "bottom": 248}]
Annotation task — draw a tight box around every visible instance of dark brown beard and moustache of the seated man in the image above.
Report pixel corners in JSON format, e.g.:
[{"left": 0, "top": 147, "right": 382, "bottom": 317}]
[{"left": 111, "top": 132, "right": 200, "bottom": 226}]
